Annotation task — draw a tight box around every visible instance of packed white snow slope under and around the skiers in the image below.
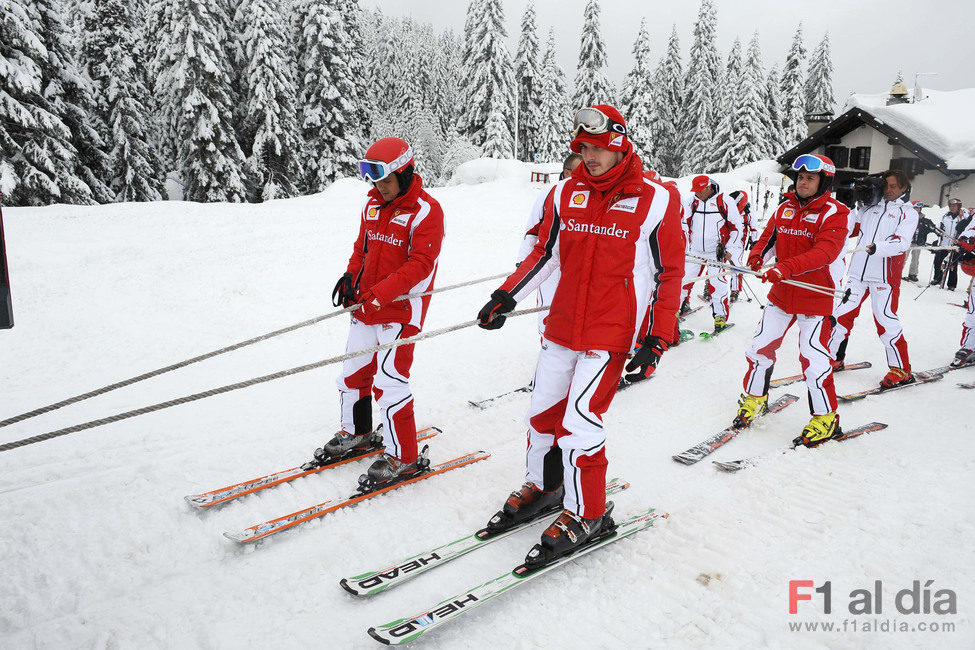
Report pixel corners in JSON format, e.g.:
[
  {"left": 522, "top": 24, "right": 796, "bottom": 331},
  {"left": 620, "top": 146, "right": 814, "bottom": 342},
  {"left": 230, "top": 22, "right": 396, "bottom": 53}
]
[{"left": 0, "top": 172, "right": 975, "bottom": 648}]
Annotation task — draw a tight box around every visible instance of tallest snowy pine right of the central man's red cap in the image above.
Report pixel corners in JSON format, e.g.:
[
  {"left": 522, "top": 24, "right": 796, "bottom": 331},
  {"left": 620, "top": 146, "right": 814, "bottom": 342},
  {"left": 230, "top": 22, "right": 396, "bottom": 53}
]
[{"left": 683, "top": 0, "right": 721, "bottom": 174}]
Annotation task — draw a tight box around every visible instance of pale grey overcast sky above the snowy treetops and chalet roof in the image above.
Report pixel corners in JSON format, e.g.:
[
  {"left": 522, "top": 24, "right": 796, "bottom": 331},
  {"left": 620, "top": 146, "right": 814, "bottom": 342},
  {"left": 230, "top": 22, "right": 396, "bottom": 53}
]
[{"left": 361, "top": 0, "right": 975, "bottom": 110}]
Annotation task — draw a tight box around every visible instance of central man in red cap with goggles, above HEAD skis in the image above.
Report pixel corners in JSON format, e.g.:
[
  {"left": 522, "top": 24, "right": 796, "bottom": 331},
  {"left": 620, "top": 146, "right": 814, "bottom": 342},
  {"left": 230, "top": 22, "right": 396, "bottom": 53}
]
[{"left": 478, "top": 104, "right": 685, "bottom": 565}]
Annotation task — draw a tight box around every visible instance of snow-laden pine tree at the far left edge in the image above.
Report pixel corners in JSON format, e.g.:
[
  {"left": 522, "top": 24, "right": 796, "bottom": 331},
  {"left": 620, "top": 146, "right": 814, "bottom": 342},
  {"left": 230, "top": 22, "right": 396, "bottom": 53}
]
[{"left": 0, "top": 0, "right": 91, "bottom": 205}]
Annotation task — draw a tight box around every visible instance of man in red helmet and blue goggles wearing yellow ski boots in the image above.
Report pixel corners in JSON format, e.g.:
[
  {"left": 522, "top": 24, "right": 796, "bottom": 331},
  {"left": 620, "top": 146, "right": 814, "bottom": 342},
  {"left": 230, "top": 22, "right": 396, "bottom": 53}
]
[{"left": 733, "top": 154, "right": 850, "bottom": 447}]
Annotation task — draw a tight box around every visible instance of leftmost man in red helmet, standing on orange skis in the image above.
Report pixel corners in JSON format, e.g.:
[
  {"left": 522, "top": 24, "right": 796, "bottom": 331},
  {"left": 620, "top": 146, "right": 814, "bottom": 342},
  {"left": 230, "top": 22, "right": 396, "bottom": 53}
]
[{"left": 315, "top": 138, "right": 444, "bottom": 483}]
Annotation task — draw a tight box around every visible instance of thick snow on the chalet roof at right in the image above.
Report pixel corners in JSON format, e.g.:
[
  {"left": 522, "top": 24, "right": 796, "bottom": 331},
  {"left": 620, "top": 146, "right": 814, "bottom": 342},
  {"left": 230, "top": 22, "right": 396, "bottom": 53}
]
[{"left": 844, "top": 88, "right": 975, "bottom": 170}]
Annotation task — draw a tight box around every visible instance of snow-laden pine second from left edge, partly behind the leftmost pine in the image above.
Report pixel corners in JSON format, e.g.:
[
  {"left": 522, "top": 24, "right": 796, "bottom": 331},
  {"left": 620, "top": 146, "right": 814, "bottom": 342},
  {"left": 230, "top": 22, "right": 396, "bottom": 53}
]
[{"left": 29, "top": 0, "right": 113, "bottom": 203}]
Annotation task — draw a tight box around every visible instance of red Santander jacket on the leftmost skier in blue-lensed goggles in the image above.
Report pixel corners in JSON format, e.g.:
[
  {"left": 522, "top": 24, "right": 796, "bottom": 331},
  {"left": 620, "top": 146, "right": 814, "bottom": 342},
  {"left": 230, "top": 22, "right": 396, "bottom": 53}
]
[{"left": 346, "top": 174, "right": 443, "bottom": 331}]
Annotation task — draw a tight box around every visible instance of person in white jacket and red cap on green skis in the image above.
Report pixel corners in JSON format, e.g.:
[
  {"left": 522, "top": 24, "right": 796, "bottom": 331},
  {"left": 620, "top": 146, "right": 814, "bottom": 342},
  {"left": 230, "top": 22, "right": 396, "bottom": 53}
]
[{"left": 681, "top": 175, "right": 745, "bottom": 332}]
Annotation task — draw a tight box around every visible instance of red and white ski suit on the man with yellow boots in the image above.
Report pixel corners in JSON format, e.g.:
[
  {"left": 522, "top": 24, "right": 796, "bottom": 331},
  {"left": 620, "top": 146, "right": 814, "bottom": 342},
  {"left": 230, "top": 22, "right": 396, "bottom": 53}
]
[{"left": 742, "top": 193, "right": 850, "bottom": 415}]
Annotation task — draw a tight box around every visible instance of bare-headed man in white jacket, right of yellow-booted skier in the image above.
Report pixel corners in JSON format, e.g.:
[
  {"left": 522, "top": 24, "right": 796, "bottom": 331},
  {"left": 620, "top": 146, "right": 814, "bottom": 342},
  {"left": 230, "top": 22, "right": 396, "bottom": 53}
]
[{"left": 829, "top": 170, "right": 918, "bottom": 388}]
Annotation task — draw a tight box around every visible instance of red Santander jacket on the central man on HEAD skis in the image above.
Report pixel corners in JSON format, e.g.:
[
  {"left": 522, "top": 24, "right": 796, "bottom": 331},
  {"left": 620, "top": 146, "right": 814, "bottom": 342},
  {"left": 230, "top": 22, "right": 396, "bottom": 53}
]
[{"left": 501, "top": 154, "right": 685, "bottom": 352}]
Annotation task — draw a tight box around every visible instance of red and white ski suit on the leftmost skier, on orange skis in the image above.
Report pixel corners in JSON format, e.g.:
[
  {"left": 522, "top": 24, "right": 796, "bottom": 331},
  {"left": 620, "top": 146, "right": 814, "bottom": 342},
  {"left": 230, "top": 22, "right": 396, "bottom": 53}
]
[{"left": 336, "top": 174, "right": 444, "bottom": 462}]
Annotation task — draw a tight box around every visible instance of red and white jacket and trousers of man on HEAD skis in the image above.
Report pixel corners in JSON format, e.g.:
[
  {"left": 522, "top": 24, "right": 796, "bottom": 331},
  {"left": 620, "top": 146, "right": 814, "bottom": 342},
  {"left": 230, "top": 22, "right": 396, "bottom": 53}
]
[{"left": 501, "top": 152, "right": 685, "bottom": 519}]
